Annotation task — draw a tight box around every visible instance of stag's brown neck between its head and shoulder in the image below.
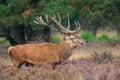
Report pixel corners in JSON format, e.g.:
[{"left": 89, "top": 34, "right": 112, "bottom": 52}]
[{"left": 58, "top": 40, "right": 73, "bottom": 61}]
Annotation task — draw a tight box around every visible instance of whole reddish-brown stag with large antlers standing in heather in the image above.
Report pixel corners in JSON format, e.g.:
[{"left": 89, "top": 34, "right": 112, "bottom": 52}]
[{"left": 8, "top": 14, "right": 85, "bottom": 67}]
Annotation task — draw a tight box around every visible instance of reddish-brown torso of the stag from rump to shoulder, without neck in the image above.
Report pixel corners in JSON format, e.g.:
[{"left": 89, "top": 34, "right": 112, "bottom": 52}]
[{"left": 8, "top": 43, "right": 61, "bottom": 66}]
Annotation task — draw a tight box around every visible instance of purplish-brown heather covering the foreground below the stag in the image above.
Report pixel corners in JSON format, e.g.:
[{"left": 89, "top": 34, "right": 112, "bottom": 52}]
[{"left": 0, "top": 53, "right": 120, "bottom": 80}]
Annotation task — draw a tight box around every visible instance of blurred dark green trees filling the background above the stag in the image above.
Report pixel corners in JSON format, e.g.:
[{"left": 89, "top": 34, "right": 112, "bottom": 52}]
[{"left": 0, "top": 0, "right": 120, "bottom": 45}]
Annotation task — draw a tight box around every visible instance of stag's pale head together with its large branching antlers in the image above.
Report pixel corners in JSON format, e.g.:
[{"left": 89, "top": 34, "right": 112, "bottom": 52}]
[{"left": 34, "top": 13, "right": 85, "bottom": 47}]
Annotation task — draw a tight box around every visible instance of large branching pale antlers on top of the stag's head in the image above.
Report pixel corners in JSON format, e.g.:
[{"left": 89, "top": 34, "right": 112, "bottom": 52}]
[{"left": 34, "top": 13, "right": 81, "bottom": 34}]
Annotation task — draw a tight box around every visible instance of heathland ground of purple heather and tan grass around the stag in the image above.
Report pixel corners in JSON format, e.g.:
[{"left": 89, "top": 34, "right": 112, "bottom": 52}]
[{"left": 0, "top": 40, "right": 120, "bottom": 80}]
